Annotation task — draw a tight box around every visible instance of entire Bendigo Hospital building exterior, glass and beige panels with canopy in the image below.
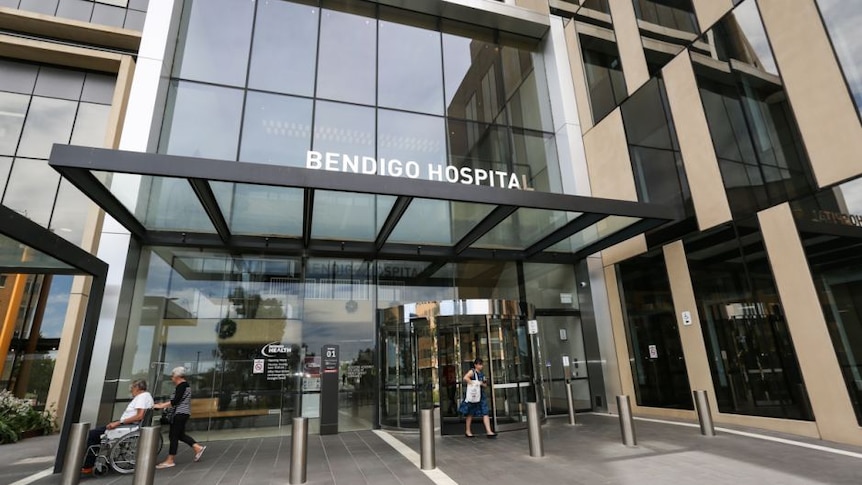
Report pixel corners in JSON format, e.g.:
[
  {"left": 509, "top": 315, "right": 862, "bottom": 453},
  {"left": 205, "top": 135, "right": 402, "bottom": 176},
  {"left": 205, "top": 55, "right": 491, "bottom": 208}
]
[{"left": 0, "top": 0, "right": 862, "bottom": 466}]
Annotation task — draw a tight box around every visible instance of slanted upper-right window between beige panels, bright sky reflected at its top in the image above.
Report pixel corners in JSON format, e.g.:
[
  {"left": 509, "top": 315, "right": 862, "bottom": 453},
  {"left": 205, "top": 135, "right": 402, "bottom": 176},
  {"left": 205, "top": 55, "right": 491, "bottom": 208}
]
[{"left": 693, "top": 0, "right": 815, "bottom": 216}]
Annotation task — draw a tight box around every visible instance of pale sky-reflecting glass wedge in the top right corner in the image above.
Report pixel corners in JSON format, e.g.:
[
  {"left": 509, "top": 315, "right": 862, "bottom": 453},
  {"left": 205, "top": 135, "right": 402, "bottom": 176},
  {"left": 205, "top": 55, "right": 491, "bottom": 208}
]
[{"left": 817, "top": 0, "right": 862, "bottom": 112}]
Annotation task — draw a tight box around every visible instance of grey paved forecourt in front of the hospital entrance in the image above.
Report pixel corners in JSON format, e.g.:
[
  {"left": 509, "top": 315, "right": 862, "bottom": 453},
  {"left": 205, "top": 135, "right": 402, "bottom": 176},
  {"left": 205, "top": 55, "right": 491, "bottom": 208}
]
[{"left": 5, "top": 414, "right": 862, "bottom": 485}]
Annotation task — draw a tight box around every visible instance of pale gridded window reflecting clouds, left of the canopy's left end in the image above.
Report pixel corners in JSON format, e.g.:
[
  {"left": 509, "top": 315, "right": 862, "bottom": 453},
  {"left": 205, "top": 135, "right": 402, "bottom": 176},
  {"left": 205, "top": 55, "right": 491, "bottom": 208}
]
[{"left": 0, "top": 59, "right": 116, "bottom": 244}]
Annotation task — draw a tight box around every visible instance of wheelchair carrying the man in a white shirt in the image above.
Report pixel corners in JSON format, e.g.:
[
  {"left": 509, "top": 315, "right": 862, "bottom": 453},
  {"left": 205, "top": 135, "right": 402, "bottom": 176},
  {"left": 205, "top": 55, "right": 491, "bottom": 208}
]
[{"left": 87, "top": 409, "right": 163, "bottom": 476}]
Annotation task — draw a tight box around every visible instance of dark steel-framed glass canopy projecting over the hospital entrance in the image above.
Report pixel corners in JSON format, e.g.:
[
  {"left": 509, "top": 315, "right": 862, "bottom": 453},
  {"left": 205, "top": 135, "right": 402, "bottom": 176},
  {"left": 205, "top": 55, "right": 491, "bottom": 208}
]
[{"left": 50, "top": 145, "right": 676, "bottom": 263}]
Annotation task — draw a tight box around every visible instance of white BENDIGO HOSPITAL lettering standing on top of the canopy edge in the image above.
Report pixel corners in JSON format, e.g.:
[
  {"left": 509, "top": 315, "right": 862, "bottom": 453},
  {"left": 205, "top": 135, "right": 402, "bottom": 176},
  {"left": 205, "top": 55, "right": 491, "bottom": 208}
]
[{"left": 305, "top": 150, "right": 533, "bottom": 190}]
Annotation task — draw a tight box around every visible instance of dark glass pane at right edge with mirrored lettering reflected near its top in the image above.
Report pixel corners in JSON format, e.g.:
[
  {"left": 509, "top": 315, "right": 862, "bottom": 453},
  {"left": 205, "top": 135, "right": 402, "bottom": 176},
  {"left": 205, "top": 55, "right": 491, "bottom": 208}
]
[{"left": 791, "top": 179, "right": 862, "bottom": 424}]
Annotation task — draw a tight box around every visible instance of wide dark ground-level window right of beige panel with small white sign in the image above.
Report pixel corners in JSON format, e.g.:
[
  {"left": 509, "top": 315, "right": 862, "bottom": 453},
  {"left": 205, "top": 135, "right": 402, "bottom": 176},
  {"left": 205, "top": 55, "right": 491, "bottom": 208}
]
[{"left": 684, "top": 219, "right": 814, "bottom": 420}]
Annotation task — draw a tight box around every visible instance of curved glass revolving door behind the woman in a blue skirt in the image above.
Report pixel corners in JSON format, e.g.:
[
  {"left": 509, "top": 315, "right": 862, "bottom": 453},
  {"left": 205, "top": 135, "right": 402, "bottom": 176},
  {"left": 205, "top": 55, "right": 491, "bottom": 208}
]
[{"left": 379, "top": 300, "right": 536, "bottom": 434}]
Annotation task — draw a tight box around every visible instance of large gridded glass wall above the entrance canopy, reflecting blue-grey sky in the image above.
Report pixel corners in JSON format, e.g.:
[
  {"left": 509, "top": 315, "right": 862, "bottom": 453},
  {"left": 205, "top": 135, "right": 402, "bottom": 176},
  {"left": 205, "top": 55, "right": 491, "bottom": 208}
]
[{"left": 159, "top": 0, "right": 562, "bottom": 192}]
